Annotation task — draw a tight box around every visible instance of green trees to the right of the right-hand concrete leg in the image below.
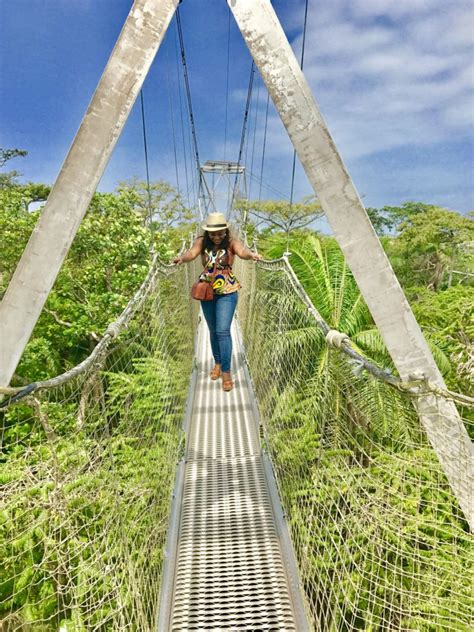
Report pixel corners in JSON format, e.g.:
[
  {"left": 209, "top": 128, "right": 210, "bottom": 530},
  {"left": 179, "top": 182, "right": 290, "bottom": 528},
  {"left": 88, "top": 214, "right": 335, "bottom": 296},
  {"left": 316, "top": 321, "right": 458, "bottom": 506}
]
[{"left": 372, "top": 202, "right": 474, "bottom": 393}]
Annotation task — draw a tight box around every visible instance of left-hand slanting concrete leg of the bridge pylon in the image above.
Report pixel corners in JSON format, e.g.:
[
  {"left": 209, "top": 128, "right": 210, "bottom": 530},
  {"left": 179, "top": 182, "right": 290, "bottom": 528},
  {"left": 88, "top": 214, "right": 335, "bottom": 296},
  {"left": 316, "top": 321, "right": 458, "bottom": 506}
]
[{"left": 0, "top": 0, "right": 179, "bottom": 386}]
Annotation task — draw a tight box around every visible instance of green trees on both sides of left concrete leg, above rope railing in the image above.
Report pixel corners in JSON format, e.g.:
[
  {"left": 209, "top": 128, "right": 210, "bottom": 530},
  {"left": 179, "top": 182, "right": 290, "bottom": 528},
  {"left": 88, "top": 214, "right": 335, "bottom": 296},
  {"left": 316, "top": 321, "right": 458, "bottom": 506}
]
[{"left": 0, "top": 185, "right": 161, "bottom": 384}]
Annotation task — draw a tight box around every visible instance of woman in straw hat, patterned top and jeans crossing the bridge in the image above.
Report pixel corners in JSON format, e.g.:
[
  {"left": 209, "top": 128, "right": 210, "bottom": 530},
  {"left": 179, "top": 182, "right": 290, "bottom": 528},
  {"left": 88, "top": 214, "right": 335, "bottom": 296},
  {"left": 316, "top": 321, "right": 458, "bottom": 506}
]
[{"left": 173, "top": 213, "right": 262, "bottom": 391}]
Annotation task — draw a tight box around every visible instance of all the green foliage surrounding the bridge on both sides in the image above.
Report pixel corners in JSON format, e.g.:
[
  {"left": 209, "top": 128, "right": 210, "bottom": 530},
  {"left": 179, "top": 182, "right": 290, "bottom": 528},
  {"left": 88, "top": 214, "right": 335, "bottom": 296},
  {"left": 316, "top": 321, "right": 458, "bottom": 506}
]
[{"left": 0, "top": 182, "right": 473, "bottom": 632}]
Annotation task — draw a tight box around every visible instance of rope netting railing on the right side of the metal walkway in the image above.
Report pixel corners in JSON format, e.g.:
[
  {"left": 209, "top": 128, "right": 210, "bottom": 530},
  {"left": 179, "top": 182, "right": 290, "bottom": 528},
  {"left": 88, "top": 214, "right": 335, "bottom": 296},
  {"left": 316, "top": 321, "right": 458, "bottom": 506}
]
[{"left": 237, "top": 258, "right": 474, "bottom": 632}]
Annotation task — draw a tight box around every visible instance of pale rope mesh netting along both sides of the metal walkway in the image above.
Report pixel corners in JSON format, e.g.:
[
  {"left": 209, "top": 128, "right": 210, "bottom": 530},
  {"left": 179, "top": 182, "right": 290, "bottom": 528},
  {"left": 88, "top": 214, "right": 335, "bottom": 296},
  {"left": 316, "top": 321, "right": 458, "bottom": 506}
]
[{"left": 0, "top": 248, "right": 474, "bottom": 632}]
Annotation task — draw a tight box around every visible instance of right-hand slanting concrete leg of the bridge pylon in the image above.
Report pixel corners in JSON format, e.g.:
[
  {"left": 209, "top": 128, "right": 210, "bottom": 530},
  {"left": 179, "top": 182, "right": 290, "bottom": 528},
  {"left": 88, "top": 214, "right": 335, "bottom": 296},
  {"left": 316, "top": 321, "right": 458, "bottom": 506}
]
[{"left": 228, "top": 0, "right": 474, "bottom": 528}]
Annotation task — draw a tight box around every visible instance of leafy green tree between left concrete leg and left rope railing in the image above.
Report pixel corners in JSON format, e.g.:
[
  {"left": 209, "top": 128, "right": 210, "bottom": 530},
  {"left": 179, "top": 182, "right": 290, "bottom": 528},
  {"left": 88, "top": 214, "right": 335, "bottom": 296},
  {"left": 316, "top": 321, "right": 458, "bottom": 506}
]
[{"left": 17, "top": 192, "right": 156, "bottom": 378}]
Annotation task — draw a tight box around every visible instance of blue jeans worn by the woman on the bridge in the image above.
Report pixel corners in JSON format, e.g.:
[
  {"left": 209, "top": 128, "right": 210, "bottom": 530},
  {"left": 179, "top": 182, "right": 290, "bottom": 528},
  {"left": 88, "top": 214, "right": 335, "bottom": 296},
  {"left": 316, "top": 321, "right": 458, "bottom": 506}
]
[{"left": 201, "top": 292, "right": 237, "bottom": 373}]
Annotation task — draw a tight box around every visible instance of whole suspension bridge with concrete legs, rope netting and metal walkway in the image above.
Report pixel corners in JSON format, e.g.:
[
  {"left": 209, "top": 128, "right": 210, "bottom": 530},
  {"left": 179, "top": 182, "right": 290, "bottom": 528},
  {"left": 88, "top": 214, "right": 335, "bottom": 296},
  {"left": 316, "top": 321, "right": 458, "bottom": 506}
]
[{"left": 0, "top": 0, "right": 473, "bottom": 632}]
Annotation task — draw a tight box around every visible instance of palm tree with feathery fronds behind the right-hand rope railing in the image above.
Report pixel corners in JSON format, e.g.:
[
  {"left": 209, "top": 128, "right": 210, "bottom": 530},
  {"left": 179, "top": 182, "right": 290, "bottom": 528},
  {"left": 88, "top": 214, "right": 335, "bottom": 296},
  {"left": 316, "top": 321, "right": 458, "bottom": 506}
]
[{"left": 265, "top": 234, "right": 418, "bottom": 436}]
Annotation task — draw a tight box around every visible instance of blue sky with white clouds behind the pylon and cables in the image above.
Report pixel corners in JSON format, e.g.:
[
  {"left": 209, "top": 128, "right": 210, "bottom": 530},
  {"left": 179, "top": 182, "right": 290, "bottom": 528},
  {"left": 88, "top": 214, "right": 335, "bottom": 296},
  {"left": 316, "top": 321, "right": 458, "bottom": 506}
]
[{"left": 0, "top": 0, "right": 474, "bottom": 212}]
